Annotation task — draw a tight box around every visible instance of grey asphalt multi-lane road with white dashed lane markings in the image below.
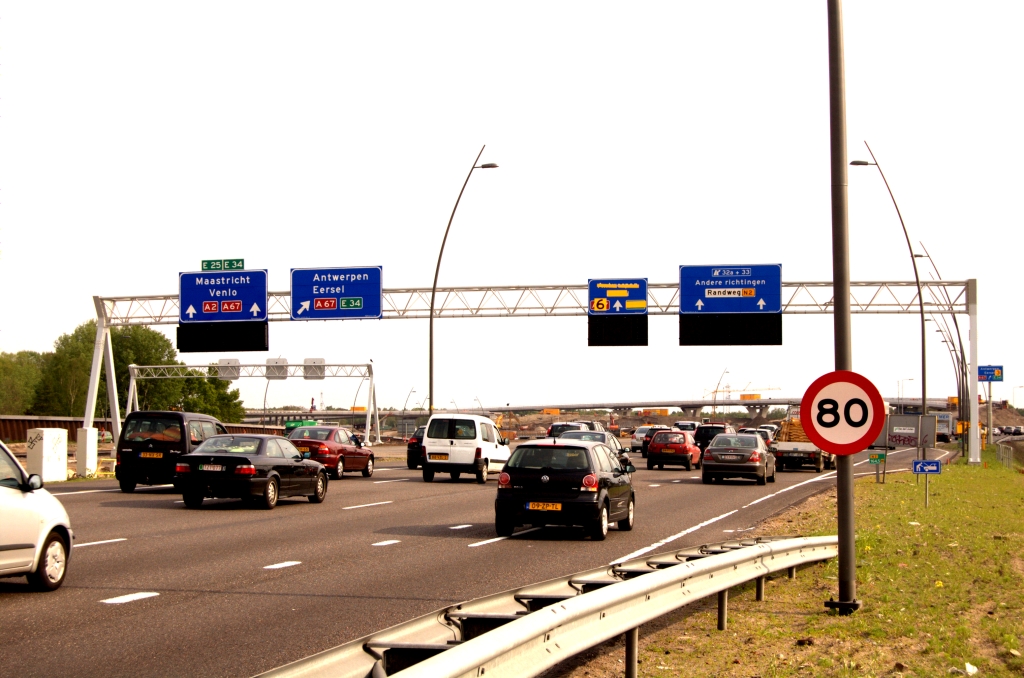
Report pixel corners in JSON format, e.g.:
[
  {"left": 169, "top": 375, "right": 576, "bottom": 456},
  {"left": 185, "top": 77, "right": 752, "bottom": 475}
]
[{"left": 0, "top": 452, "right": 946, "bottom": 678}]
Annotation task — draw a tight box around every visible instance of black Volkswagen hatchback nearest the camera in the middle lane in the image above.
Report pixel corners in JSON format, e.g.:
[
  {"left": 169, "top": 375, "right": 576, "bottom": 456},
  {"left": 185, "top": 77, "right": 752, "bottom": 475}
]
[{"left": 495, "top": 438, "right": 636, "bottom": 541}]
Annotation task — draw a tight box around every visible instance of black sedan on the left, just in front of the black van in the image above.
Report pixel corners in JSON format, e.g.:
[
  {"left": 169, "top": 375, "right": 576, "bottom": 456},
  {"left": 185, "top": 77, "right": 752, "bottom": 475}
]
[{"left": 174, "top": 434, "right": 328, "bottom": 509}]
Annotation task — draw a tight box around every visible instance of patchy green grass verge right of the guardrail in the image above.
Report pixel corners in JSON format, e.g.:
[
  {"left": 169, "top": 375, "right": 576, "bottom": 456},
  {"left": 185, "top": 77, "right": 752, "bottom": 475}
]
[{"left": 548, "top": 448, "right": 1024, "bottom": 678}]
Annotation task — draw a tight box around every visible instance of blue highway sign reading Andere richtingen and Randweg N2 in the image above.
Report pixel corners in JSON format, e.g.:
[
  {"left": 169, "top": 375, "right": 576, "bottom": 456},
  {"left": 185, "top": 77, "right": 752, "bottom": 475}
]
[{"left": 679, "top": 263, "right": 782, "bottom": 313}]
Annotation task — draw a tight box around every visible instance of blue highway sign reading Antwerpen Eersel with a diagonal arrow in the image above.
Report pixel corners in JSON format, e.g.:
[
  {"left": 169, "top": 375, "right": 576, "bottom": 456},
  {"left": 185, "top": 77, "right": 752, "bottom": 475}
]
[{"left": 292, "top": 266, "right": 384, "bottom": 321}]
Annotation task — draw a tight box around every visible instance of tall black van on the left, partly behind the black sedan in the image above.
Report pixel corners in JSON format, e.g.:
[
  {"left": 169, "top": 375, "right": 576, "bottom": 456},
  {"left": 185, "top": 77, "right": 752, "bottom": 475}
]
[{"left": 114, "top": 412, "right": 227, "bottom": 492}]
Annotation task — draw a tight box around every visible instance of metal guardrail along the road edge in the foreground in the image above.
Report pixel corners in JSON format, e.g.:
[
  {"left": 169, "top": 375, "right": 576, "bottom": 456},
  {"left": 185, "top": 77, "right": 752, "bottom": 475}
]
[{"left": 253, "top": 537, "right": 839, "bottom": 678}]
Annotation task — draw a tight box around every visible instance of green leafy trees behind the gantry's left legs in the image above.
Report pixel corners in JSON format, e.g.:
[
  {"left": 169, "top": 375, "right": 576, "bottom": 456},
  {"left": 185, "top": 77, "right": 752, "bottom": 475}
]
[{"left": 0, "top": 321, "right": 245, "bottom": 422}]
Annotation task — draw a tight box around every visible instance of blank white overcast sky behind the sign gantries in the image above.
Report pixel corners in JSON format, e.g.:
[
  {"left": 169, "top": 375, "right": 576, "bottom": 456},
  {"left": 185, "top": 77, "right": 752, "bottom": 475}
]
[{"left": 0, "top": 0, "right": 1024, "bottom": 408}]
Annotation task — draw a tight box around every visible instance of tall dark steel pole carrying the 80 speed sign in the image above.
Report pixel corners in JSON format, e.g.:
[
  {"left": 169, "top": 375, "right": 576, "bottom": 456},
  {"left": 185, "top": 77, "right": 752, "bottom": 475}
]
[{"left": 825, "top": 0, "right": 860, "bottom": 615}]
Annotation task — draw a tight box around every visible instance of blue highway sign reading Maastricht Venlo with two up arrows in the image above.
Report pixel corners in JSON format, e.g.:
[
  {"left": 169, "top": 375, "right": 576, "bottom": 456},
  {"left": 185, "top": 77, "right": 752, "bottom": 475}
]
[{"left": 178, "top": 270, "right": 267, "bottom": 323}]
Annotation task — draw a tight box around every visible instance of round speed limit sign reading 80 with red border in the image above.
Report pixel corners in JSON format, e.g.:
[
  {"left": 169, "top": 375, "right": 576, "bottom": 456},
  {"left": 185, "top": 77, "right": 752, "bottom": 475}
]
[{"left": 800, "top": 370, "right": 886, "bottom": 456}]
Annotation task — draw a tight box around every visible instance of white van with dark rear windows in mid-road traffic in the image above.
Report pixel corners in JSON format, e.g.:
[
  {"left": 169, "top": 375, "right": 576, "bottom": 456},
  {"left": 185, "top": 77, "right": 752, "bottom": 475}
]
[{"left": 423, "top": 413, "right": 509, "bottom": 482}]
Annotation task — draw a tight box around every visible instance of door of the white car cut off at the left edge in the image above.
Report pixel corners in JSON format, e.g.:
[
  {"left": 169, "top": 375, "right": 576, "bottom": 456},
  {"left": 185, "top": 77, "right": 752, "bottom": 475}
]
[{"left": 0, "top": 450, "right": 39, "bottom": 573}]
